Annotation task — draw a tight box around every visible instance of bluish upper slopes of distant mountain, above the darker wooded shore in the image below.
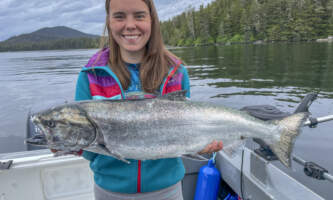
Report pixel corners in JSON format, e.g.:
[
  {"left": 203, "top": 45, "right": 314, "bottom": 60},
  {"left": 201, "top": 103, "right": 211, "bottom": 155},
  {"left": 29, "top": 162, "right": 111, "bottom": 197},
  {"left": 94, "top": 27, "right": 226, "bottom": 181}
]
[{"left": 4, "top": 26, "right": 99, "bottom": 44}]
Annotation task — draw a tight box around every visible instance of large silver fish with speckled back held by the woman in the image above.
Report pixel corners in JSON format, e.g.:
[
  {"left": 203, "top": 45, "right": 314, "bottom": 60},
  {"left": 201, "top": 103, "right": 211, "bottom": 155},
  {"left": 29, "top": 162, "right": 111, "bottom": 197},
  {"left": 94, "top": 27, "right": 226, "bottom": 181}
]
[{"left": 26, "top": 92, "right": 307, "bottom": 167}]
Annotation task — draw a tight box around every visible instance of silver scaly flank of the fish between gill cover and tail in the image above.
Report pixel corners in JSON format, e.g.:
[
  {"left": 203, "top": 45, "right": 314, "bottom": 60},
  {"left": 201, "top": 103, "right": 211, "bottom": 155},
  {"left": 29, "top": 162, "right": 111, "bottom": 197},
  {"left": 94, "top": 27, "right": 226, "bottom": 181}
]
[{"left": 80, "top": 99, "right": 274, "bottom": 159}]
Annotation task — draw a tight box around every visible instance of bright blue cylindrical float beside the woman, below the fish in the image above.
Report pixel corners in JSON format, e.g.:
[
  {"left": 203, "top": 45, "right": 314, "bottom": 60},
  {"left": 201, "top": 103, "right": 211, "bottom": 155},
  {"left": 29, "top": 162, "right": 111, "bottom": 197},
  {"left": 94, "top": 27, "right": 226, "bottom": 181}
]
[{"left": 194, "top": 159, "right": 221, "bottom": 200}]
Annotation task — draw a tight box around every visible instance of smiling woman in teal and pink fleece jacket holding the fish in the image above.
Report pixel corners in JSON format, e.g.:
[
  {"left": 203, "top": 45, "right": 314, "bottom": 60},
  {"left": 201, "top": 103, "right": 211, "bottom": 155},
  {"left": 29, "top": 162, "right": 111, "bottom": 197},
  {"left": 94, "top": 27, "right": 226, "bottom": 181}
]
[{"left": 75, "top": 0, "right": 222, "bottom": 200}]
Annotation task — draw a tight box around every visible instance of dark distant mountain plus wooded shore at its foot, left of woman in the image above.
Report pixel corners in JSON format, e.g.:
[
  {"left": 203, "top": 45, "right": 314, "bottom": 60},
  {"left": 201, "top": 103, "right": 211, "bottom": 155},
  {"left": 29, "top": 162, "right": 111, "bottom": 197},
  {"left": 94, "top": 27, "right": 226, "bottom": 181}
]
[{"left": 0, "top": 26, "right": 100, "bottom": 51}]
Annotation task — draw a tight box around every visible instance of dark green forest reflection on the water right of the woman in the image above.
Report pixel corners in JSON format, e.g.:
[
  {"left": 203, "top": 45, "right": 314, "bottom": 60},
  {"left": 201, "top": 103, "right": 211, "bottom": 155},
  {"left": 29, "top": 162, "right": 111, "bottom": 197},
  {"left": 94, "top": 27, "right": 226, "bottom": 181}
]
[{"left": 175, "top": 43, "right": 333, "bottom": 98}]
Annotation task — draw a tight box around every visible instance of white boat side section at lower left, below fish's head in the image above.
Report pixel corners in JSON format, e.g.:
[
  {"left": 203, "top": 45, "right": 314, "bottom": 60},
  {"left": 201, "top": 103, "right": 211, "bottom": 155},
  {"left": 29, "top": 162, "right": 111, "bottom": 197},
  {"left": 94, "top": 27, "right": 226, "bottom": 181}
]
[{"left": 0, "top": 150, "right": 93, "bottom": 200}]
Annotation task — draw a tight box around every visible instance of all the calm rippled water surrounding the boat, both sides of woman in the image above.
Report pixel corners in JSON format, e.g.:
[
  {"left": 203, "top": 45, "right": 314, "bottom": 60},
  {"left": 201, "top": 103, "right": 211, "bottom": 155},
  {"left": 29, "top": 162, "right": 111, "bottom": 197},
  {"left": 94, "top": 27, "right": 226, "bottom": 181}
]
[{"left": 0, "top": 43, "right": 333, "bottom": 199}]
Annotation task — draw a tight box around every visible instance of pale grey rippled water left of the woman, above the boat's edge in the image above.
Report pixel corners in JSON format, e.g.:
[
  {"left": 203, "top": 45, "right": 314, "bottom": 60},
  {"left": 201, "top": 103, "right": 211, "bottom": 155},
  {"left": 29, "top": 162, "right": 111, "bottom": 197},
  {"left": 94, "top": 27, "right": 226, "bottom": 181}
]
[{"left": 0, "top": 50, "right": 96, "bottom": 153}]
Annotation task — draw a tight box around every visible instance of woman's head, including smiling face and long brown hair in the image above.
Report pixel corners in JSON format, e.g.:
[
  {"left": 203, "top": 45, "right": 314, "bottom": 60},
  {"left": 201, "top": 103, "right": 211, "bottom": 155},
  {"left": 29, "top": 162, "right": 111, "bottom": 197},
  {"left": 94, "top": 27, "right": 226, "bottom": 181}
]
[{"left": 101, "top": 0, "right": 177, "bottom": 93}]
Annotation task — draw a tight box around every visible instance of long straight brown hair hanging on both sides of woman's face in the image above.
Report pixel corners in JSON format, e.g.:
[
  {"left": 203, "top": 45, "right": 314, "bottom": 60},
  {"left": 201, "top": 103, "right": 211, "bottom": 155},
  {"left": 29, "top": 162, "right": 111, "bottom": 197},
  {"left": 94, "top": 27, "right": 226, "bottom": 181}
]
[{"left": 100, "top": 0, "right": 177, "bottom": 93}]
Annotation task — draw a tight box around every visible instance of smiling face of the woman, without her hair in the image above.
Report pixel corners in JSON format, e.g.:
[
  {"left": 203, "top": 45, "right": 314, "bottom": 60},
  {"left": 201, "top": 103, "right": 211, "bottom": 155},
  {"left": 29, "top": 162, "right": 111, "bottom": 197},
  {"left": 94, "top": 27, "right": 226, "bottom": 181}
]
[{"left": 109, "top": 0, "right": 151, "bottom": 59}]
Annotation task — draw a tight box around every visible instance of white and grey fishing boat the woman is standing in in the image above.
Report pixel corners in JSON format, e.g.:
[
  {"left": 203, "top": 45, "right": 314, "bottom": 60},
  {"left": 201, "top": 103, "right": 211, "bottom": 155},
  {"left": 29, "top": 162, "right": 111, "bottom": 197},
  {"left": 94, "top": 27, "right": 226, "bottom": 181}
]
[{"left": 0, "top": 94, "right": 333, "bottom": 200}]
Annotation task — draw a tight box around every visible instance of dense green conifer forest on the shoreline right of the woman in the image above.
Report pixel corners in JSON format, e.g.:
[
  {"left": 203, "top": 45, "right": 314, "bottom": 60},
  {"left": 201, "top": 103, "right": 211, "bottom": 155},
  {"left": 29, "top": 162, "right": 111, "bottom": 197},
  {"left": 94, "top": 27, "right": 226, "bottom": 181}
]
[{"left": 161, "top": 0, "right": 333, "bottom": 46}]
